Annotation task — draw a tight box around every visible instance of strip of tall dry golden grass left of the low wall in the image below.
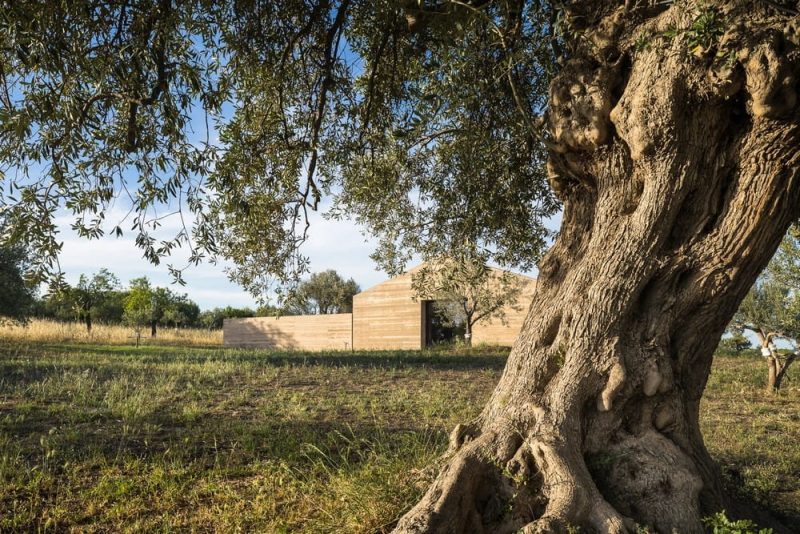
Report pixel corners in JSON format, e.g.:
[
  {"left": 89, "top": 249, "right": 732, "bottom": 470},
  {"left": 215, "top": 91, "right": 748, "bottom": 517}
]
[{"left": 0, "top": 319, "right": 222, "bottom": 347}]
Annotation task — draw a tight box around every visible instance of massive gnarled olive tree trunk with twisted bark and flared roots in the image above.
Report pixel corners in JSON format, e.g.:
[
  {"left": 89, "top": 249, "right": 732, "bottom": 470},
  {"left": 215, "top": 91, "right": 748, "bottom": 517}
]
[{"left": 396, "top": 1, "right": 800, "bottom": 534}]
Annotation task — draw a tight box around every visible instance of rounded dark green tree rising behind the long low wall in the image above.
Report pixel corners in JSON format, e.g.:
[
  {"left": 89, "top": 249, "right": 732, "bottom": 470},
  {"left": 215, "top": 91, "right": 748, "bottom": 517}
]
[{"left": 285, "top": 269, "right": 361, "bottom": 315}]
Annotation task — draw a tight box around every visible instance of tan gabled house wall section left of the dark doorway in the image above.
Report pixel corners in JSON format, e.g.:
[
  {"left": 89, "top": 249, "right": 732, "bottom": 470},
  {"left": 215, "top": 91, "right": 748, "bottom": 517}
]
[{"left": 353, "top": 270, "right": 425, "bottom": 350}]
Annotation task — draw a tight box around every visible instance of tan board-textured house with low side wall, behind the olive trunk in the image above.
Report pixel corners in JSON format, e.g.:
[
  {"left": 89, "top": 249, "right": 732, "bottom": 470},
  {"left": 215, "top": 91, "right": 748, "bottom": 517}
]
[{"left": 223, "top": 267, "right": 536, "bottom": 350}]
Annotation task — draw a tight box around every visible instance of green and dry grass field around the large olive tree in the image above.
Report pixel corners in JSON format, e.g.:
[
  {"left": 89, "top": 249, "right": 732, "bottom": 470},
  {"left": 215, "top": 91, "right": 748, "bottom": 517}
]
[{"left": 0, "top": 341, "right": 800, "bottom": 533}]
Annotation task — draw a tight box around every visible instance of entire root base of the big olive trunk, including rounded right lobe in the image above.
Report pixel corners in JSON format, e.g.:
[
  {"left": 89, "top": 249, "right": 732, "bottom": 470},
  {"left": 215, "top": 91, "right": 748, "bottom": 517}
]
[{"left": 395, "top": 427, "right": 716, "bottom": 534}]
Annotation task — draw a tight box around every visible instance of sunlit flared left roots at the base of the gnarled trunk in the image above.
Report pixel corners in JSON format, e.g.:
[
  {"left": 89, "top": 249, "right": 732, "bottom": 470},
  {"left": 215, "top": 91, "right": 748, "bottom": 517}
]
[{"left": 395, "top": 427, "right": 634, "bottom": 534}]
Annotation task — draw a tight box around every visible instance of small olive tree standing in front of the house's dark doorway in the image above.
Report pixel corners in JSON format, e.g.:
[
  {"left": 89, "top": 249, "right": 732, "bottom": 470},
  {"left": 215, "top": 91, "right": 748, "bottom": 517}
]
[{"left": 411, "top": 253, "right": 522, "bottom": 345}]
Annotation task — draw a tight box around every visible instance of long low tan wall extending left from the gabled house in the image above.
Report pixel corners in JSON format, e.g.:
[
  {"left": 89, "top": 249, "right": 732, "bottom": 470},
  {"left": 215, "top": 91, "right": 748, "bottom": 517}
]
[{"left": 223, "top": 313, "right": 353, "bottom": 350}]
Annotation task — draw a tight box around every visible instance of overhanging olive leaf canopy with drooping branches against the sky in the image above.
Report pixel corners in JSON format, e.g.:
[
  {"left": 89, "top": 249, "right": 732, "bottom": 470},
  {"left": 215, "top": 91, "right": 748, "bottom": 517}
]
[{"left": 0, "top": 0, "right": 557, "bottom": 293}]
